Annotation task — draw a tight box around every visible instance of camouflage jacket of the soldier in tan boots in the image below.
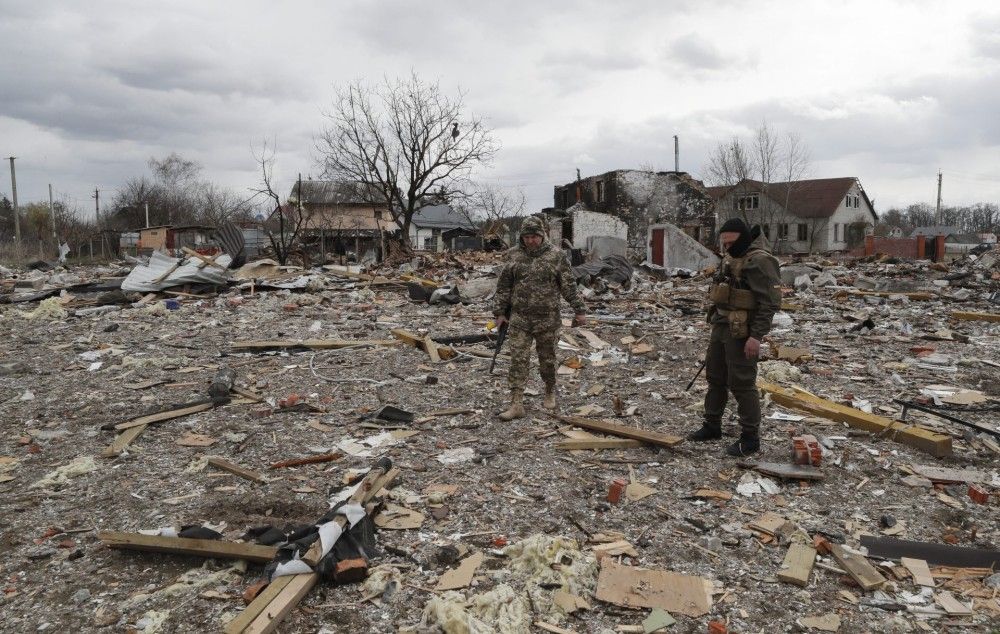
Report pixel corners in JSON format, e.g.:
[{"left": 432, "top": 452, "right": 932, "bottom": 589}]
[{"left": 493, "top": 241, "right": 587, "bottom": 317}]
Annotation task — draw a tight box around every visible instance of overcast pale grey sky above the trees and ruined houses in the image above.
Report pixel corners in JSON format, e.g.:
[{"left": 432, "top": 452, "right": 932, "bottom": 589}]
[{"left": 0, "top": 0, "right": 1000, "bottom": 220}]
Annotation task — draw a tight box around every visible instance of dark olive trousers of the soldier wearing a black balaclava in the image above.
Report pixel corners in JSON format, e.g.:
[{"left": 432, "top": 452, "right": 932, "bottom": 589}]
[{"left": 705, "top": 323, "right": 760, "bottom": 438}]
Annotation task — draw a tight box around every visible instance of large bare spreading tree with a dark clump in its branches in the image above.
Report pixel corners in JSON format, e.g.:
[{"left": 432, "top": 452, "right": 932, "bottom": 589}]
[{"left": 317, "top": 73, "right": 498, "bottom": 247}]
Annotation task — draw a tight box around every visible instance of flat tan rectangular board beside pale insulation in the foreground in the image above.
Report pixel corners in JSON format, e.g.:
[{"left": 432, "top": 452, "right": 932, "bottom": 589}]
[{"left": 596, "top": 557, "right": 712, "bottom": 618}]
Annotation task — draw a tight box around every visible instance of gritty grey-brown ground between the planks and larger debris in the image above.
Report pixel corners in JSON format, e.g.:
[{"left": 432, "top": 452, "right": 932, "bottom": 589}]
[{"left": 0, "top": 249, "right": 1000, "bottom": 633}]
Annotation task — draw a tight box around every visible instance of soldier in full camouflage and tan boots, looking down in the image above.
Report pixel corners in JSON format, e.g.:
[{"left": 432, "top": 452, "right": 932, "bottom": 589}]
[{"left": 493, "top": 216, "right": 587, "bottom": 420}]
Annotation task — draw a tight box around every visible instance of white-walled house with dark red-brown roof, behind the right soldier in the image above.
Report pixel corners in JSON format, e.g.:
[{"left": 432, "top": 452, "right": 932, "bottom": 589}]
[{"left": 708, "top": 177, "right": 878, "bottom": 253}]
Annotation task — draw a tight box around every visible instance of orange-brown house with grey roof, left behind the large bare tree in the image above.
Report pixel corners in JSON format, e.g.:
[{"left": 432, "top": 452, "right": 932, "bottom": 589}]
[{"left": 286, "top": 179, "right": 399, "bottom": 260}]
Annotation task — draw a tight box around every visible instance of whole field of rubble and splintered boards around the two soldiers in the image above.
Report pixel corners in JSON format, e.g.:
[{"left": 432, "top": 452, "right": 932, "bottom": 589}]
[{"left": 0, "top": 250, "right": 1000, "bottom": 634}]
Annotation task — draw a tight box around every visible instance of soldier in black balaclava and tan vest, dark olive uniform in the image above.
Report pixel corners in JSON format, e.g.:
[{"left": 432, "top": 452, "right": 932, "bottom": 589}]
[{"left": 688, "top": 218, "right": 781, "bottom": 456}]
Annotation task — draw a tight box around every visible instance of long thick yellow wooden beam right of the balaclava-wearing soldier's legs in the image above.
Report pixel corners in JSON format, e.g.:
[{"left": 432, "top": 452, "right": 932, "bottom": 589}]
[{"left": 757, "top": 381, "right": 951, "bottom": 457}]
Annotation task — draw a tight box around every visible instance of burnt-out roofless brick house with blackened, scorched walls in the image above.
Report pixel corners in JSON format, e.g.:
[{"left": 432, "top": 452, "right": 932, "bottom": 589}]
[{"left": 554, "top": 170, "right": 715, "bottom": 257}]
